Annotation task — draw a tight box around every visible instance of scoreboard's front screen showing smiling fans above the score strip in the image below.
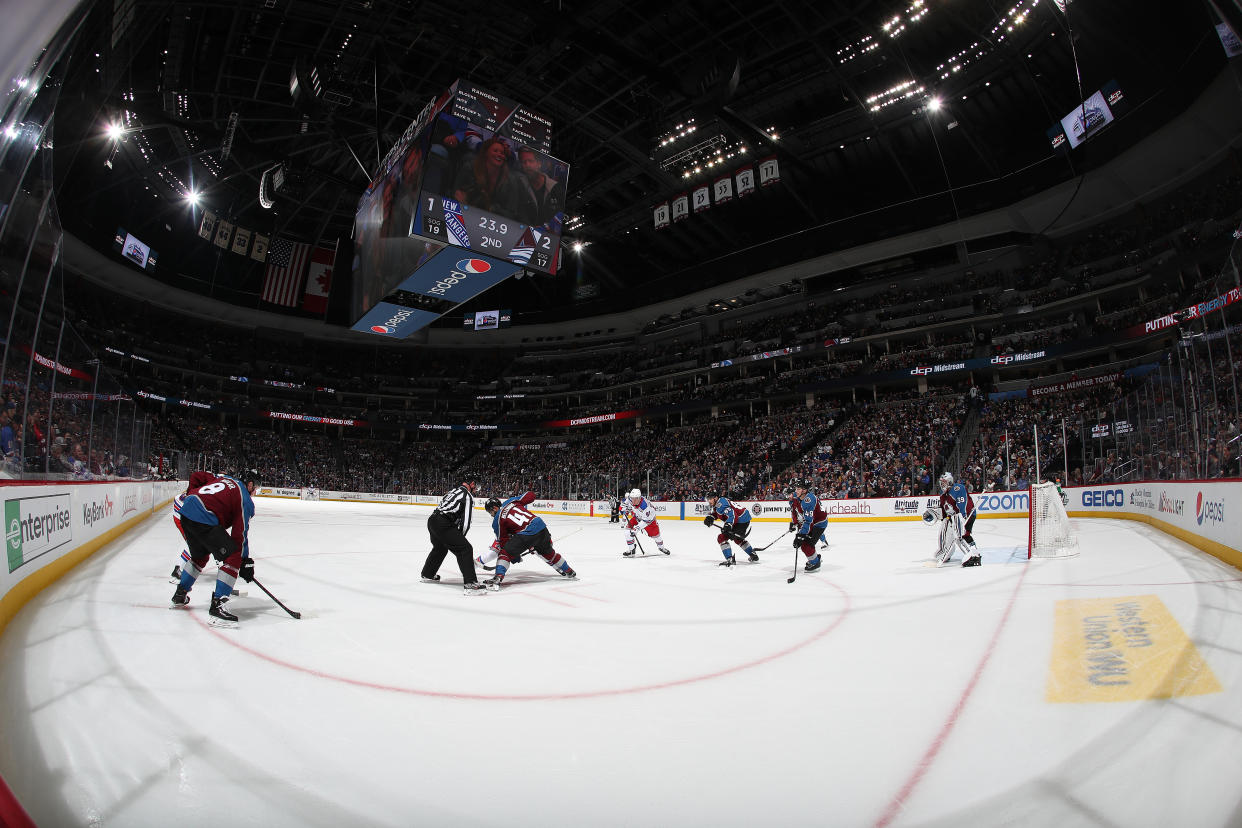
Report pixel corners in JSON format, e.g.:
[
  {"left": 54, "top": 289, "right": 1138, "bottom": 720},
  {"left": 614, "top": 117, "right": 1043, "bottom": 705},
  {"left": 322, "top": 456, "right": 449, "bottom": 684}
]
[{"left": 410, "top": 108, "right": 569, "bottom": 273}]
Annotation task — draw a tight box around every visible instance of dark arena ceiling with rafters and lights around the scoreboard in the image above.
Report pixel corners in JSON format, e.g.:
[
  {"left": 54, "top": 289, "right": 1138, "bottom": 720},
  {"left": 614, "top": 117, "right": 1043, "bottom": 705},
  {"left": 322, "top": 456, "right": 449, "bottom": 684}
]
[{"left": 48, "top": 0, "right": 1225, "bottom": 320}]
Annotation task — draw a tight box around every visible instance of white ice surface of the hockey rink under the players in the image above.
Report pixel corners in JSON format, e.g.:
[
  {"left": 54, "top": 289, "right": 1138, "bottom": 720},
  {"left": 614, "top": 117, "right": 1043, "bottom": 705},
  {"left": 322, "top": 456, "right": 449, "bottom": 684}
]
[{"left": 0, "top": 499, "right": 1242, "bottom": 828}]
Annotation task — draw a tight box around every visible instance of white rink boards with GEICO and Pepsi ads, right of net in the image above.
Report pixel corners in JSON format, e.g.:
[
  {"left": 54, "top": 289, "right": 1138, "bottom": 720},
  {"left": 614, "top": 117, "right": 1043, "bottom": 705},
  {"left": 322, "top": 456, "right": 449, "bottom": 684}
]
[{"left": 1068, "top": 480, "right": 1242, "bottom": 549}]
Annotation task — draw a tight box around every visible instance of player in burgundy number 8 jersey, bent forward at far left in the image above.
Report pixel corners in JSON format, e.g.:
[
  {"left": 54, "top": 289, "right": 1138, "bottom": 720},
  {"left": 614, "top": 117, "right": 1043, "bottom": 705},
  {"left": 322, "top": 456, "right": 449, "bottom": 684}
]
[{"left": 173, "top": 475, "right": 255, "bottom": 627}]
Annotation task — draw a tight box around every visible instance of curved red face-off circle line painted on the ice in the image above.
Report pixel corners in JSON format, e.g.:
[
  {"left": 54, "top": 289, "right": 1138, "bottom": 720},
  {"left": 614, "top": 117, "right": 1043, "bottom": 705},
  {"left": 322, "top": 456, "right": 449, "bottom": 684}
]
[{"left": 191, "top": 578, "right": 853, "bottom": 701}]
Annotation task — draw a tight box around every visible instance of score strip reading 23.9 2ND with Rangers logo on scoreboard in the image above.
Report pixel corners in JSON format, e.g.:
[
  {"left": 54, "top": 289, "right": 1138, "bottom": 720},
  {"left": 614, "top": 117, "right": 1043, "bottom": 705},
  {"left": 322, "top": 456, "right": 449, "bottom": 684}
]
[{"left": 415, "top": 190, "right": 560, "bottom": 273}]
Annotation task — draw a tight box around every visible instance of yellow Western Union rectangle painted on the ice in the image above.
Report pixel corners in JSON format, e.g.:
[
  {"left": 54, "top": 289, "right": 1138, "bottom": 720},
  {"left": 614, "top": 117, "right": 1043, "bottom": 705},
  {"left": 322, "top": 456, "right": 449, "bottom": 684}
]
[{"left": 1047, "top": 595, "right": 1221, "bottom": 703}]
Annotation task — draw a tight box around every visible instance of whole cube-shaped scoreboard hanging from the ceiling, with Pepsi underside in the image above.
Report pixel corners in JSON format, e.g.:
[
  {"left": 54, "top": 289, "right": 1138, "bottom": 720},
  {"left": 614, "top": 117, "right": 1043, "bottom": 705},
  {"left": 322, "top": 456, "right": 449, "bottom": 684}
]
[{"left": 351, "top": 81, "right": 569, "bottom": 339}]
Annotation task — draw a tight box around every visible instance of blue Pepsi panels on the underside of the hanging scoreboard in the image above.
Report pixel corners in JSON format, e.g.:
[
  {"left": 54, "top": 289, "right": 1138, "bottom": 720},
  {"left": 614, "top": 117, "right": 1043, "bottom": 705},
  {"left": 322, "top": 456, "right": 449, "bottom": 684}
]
[{"left": 351, "top": 247, "right": 522, "bottom": 339}]
